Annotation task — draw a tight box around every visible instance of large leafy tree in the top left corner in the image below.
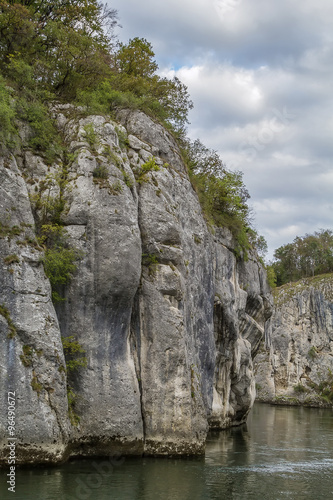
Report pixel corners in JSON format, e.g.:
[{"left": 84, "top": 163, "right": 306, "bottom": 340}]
[{"left": 0, "top": 0, "right": 117, "bottom": 98}]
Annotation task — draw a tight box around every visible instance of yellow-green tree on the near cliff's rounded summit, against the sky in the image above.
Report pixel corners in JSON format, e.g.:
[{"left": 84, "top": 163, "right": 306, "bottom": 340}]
[{"left": 80, "top": 37, "right": 193, "bottom": 136}]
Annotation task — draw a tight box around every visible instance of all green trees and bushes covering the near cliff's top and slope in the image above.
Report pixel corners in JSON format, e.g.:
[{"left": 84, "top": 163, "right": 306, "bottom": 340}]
[{"left": 0, "top": 0, "right": 260, "bottom": 255}]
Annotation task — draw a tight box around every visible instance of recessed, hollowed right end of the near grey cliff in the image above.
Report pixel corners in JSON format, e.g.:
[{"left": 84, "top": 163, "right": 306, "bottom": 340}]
[{"left": 210, "top": 235, "right": 272, "bottom": 428}]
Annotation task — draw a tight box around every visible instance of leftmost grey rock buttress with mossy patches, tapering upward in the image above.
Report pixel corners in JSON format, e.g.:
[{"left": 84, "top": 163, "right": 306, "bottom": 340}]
[{"left": 0, "top": 158, "right": 69, "bottom": 463}]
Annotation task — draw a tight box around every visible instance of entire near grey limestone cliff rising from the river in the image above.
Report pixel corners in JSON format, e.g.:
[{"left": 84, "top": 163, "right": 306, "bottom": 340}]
[{"left": 0, "top": 106, "right": 271, "bottom": 463}]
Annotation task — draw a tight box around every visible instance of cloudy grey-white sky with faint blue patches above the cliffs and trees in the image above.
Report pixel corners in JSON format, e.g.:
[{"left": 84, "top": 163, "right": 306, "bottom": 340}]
[{"left": 108, "top": 0, "right": 333, "bottom": 258}]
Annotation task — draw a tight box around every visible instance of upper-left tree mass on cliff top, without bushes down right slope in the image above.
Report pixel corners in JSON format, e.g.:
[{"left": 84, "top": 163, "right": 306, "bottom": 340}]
[{"left": 0, "top": 0, "right": 192, "bottom": 145}]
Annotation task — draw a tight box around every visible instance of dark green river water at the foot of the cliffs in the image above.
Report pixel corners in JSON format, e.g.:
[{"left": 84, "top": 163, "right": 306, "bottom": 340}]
[{"left": 0, "top": 404, "right": 333, "bottom": 500}]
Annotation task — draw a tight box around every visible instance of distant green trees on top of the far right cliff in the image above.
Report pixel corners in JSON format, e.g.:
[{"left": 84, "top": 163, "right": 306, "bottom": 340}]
[{"left": 268, "top": 229, "right": 333, "bottom": 286}]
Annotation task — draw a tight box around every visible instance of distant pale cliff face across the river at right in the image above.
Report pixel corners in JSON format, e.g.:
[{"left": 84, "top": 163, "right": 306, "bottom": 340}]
[{"left": 255, "top": 275, "right": 333, "bottom": 406}]
